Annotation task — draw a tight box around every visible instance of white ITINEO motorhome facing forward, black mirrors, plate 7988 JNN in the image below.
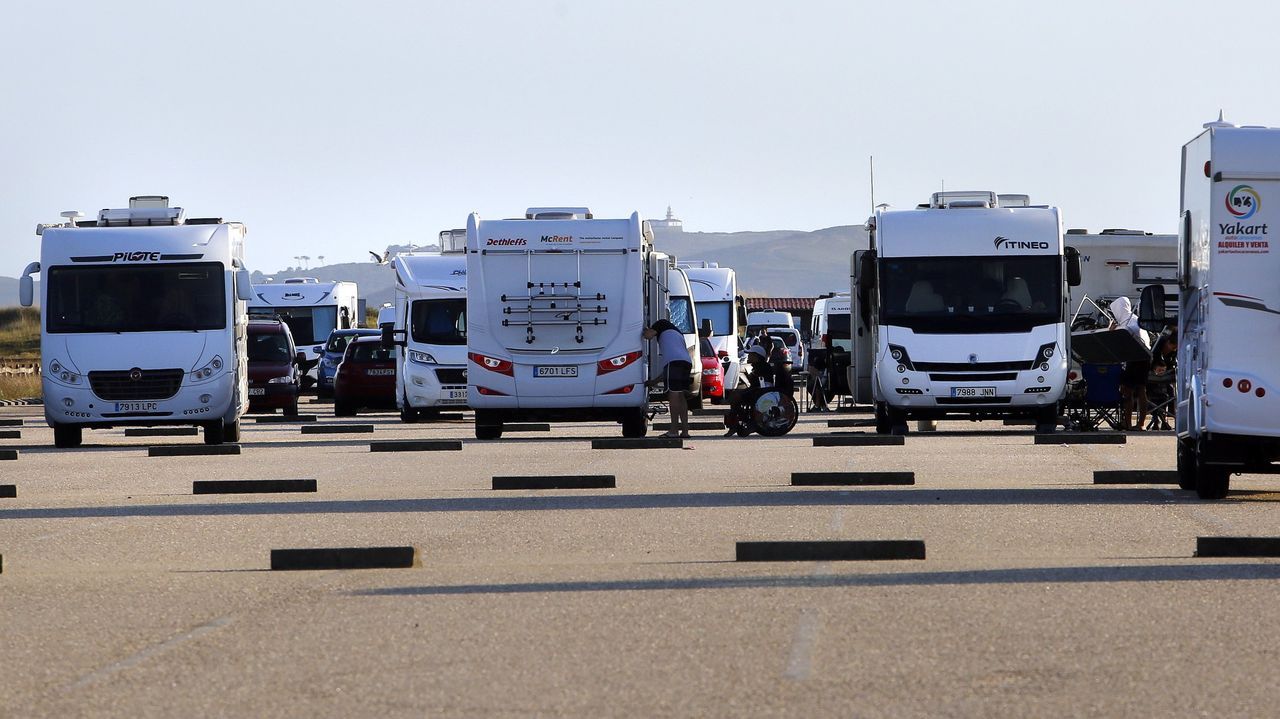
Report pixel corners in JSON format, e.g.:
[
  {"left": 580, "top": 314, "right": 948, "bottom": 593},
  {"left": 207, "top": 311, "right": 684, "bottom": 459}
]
[{"left": 852, "top": 192, "right": 1079, "bottom": 434}]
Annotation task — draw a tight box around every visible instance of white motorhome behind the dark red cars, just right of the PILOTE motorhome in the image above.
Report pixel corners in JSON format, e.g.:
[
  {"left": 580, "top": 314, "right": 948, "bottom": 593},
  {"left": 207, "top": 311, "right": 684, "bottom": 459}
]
[{"left": 248, "top": 278, "right": 365, "bottom": 380}]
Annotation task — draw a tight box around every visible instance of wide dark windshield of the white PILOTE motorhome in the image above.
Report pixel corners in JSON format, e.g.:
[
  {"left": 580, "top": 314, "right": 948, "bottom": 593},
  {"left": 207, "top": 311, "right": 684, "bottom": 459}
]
[{"left": 45, "top": 262, "right": 227, "bottom": 334}]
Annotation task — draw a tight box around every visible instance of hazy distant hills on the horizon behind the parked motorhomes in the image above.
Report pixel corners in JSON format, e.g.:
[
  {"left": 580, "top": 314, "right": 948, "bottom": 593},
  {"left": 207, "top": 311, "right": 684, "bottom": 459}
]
[{"left": 0, "top": 225, "right": 867, "bottom": 307}]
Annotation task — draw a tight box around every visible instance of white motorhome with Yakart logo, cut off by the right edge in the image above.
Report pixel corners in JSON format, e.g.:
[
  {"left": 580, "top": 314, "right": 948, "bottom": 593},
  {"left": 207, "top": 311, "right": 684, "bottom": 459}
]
[{"left": 1175, "top": 119, "right": 1280, "bottom": 499}]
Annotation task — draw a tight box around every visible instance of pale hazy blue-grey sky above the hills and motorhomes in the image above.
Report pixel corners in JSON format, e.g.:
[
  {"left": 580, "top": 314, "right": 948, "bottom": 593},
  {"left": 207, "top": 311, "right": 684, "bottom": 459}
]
[{"left": 0, "top": 0, "right": 1280, "bottom": 276}]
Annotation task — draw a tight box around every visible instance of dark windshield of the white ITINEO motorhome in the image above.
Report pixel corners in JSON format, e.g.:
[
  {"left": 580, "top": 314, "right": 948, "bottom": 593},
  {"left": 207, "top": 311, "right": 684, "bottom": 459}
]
[{"left": 879, "top": 255, "right": 1062, "bottom": 334}]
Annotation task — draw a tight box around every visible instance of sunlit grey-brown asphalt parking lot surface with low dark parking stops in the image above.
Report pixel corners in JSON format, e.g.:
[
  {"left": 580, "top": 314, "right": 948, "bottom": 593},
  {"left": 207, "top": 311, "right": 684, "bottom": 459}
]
[{"left": 0, "top": 404, "right": 1280, "bottom": 716}]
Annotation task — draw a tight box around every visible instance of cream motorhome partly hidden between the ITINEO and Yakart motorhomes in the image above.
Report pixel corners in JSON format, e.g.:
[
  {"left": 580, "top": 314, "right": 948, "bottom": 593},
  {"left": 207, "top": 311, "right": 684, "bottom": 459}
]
[{"left": 1065, "top": 229, "right": 1178, "bottom": 328}]
